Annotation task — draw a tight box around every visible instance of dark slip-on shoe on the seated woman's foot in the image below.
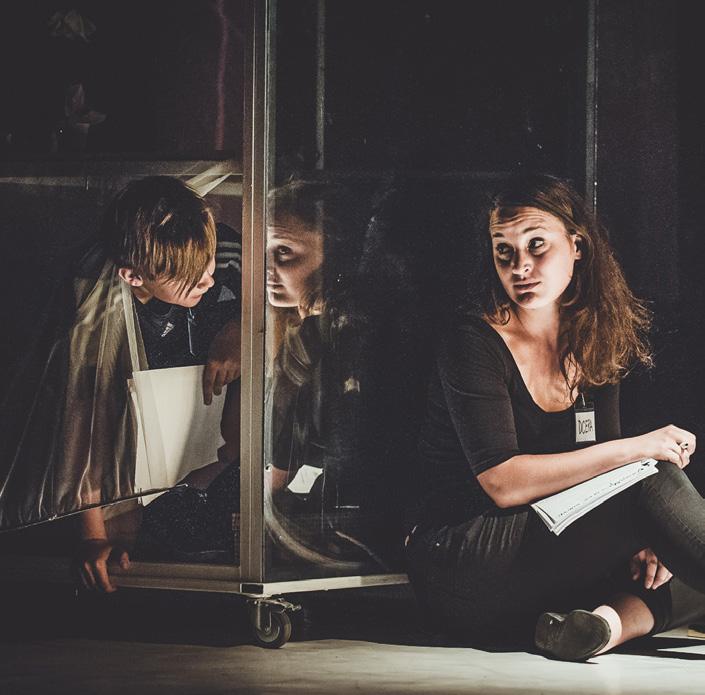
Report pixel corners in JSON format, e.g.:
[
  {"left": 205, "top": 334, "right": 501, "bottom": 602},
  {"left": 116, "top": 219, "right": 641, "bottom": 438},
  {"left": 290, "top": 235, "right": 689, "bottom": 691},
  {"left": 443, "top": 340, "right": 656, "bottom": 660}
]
[{"left": 534, "top": 610, "right": 612, "bottom": 661}]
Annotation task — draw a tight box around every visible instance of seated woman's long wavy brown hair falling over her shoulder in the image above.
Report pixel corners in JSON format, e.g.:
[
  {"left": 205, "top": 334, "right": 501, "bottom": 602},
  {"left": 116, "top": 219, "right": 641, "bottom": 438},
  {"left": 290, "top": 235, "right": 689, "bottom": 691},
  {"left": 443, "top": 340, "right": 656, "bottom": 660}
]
[{"left": 479, "top": 174, "right": 652, "bottom": 393}]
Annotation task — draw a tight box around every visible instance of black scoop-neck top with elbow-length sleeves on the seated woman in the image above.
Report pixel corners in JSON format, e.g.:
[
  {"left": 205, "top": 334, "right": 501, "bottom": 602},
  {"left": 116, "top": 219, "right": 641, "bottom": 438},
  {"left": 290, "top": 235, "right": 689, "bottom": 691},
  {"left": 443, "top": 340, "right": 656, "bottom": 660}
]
[{"left": 415, "top": 318, "right": 621, "bottom": 524}]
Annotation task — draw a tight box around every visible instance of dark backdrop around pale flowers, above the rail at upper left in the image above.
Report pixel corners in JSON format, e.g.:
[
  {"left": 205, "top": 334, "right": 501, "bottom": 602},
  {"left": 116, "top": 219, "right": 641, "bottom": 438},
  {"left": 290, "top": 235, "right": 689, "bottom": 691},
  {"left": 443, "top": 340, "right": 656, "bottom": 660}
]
[{"left": 0, "top": 0, "right": 245, "bottom": 158}]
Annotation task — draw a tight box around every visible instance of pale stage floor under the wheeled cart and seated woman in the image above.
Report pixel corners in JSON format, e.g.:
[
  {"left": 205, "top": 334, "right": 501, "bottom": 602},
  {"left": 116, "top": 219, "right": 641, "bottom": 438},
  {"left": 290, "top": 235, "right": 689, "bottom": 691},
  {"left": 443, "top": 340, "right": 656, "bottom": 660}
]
[{"left": 0, "top": 587, "right": 705, "bottom": 695}]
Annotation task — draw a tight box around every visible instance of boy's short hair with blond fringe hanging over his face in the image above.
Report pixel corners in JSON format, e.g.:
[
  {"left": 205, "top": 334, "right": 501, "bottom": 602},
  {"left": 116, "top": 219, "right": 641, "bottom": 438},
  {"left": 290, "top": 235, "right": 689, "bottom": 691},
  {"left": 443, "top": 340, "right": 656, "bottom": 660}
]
[{"left": 102, "top": 176, "right": 216, "bottom": 292}]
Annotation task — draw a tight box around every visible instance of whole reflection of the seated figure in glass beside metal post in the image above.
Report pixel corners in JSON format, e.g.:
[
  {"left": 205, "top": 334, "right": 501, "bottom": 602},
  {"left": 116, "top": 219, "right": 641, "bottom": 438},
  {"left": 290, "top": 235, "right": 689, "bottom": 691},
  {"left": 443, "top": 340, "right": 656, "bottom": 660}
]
[{"left": 265, "top": 180, "right": 394, "bottom": 573}]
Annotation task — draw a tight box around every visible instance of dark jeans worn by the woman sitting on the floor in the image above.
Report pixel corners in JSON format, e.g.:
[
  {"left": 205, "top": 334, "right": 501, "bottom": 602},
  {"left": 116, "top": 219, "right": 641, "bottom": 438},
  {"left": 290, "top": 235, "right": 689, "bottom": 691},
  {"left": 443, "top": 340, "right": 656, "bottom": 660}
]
[{"left": 407, "top": 462, "right": 705, "bottom": 644}]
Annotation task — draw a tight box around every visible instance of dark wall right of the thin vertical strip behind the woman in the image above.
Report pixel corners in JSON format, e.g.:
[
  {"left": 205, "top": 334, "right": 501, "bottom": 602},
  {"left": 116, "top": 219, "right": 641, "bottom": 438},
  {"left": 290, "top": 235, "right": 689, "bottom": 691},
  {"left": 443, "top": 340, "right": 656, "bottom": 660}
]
[{"left": 598, "top": 0, "right": 705, "bottom": 490}]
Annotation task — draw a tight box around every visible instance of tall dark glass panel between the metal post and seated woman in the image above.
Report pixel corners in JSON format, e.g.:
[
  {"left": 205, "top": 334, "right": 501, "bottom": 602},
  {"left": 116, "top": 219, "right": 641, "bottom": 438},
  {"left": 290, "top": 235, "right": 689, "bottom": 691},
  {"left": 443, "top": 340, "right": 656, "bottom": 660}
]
[{"left": 265, "top": 0, "right": 587, "bottom": 581}]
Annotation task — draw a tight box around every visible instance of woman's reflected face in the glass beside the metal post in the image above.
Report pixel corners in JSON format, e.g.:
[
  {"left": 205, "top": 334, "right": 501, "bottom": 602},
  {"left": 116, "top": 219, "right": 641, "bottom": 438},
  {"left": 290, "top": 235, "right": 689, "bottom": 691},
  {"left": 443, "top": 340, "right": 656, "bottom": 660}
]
[{"left": 267, "top": 217, "right": 323, "bottom": 307}]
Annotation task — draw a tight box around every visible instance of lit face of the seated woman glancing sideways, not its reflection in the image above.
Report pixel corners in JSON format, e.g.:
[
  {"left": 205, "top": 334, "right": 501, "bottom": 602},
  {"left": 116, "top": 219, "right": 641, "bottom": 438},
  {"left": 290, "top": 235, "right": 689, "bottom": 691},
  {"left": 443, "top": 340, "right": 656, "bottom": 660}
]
[{"left": 490, "top": 208, "right": 581, "bottom": 309}]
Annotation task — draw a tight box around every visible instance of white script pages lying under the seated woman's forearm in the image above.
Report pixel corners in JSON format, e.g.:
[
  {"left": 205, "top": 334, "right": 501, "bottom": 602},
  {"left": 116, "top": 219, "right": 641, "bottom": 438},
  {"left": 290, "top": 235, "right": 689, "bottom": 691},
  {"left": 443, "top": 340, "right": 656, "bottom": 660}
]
[{"left": 531, "top": 459, "right": 658, "bottom": 535}]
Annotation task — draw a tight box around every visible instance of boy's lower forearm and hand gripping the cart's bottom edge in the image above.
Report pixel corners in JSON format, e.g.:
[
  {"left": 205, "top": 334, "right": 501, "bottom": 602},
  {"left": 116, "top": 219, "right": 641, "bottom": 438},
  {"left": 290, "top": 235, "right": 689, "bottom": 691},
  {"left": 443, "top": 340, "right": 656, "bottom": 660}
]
[{"left": 76, "top": 507, "right": 130, "bottom": 593}]
